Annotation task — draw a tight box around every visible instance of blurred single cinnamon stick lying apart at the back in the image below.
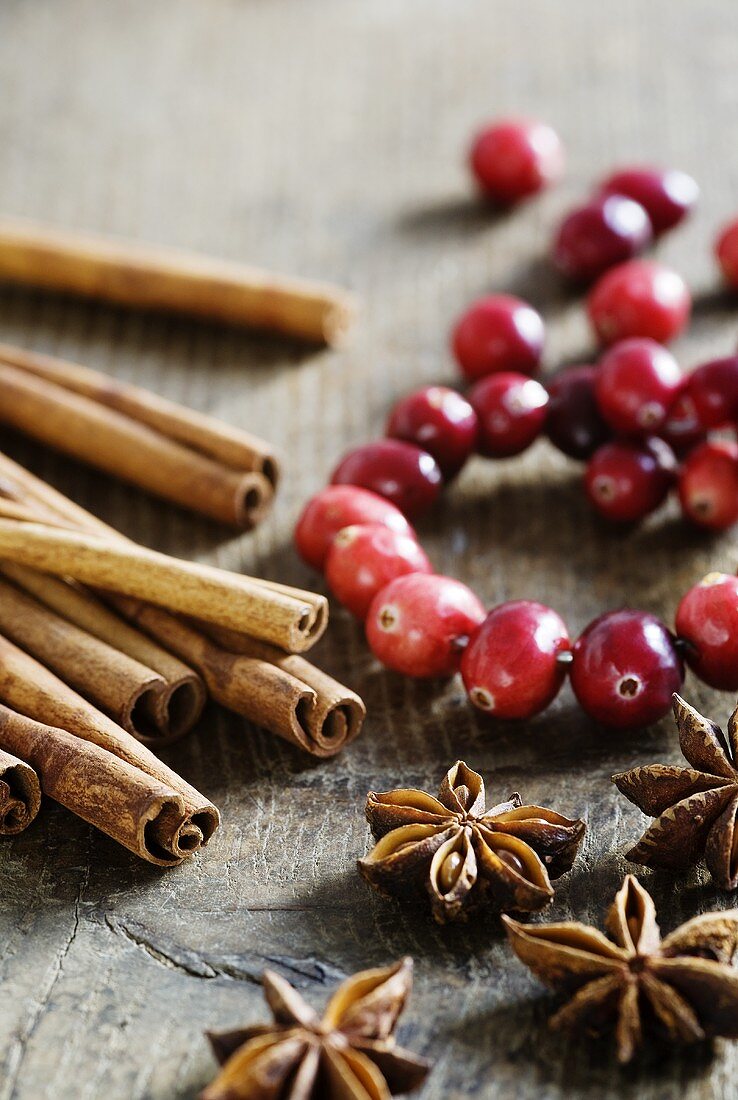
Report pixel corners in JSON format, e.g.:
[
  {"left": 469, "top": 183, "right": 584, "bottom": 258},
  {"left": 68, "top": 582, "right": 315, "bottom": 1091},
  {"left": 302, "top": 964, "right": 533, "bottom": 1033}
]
[{"left": 0, "top": 218, "right": 355, "bottom": 344}]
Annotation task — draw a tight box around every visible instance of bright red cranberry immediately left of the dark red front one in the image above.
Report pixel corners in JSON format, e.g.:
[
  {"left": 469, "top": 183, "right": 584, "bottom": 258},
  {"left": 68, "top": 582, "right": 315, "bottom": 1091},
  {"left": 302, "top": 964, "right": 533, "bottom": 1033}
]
[{"left": 461, "top": 600, "right": 571, "bottom": 718}]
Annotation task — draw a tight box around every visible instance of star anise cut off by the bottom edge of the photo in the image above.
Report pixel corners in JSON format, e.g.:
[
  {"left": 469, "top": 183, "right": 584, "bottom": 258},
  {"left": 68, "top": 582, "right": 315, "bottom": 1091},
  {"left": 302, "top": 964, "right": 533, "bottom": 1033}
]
[{"left": 200, "top": 958, "right": 430, "bottom": 1100}]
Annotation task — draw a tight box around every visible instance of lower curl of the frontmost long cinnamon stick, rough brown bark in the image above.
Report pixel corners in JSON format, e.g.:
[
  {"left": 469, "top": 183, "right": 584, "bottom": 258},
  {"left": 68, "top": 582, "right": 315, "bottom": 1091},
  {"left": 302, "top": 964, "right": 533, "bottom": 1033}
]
[{"left": 0, "top": 704, "right": 198, "bottom": 867}]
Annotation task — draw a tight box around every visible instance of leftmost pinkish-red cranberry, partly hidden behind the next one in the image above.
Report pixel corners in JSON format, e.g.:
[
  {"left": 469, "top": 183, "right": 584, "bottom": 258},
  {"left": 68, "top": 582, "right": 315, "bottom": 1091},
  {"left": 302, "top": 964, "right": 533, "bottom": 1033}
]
[{"left": 295, "top": 485, "right": 415, "bottom": 570}]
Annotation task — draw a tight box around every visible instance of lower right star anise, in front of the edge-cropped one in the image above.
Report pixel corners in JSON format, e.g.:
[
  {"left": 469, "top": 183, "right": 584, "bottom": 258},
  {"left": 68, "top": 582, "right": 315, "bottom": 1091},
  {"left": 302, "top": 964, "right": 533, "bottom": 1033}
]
[{"left": 503, "top": 875, "right": 738, "bottom": 1063}]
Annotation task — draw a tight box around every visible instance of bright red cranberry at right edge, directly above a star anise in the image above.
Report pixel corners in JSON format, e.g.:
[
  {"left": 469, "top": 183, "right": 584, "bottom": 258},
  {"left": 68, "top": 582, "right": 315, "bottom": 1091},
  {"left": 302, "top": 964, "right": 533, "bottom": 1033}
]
[{"left": 676, "top": 573, "right": 738, "bottom": 692}]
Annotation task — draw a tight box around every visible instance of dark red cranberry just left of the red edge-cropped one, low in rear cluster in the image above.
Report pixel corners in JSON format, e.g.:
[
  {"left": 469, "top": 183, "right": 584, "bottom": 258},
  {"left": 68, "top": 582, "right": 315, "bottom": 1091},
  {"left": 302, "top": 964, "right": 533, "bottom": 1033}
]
[{"left": 584, "top": 439, "right": 675, "bottom": 524}]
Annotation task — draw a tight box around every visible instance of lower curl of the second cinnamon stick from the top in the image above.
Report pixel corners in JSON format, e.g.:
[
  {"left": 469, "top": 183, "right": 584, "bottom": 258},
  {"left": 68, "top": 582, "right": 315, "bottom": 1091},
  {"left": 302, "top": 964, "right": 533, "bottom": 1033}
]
[{"left": 0, "top": 356, "right": 276, "bottom": 528}]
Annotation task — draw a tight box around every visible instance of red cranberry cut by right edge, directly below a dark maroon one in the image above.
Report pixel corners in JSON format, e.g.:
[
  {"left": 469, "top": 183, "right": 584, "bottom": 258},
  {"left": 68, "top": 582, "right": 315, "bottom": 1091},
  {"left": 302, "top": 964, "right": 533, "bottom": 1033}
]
[{"left": 679, "top": 440, "right": 738, "bottom": 531}]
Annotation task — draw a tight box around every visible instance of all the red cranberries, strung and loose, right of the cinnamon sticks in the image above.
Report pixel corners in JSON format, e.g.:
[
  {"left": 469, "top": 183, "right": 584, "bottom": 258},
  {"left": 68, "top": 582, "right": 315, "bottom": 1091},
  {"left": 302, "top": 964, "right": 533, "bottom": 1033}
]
[{"left": 295, "top": 121, "right": 738, "bottom": 729}]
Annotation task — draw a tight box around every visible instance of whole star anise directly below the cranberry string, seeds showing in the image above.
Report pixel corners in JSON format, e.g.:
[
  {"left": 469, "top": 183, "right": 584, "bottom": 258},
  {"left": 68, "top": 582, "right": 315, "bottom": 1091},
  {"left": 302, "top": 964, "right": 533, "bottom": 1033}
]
[{"left": 359, "top": 760, "right": 585, "bottom": 924}]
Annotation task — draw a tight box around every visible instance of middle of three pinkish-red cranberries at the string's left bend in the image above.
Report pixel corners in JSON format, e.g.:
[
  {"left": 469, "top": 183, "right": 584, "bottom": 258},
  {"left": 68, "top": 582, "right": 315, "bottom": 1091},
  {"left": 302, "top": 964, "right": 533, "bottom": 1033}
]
[{"left": 326, "top": 524, "right": 433, "bottom": 619}]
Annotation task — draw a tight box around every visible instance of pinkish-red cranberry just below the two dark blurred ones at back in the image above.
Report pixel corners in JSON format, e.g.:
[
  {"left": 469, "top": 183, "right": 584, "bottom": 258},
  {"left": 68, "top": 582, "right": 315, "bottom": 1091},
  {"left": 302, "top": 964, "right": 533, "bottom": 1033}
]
[{"left": 587, "top": 260, "right": 692, "bottom": 344}]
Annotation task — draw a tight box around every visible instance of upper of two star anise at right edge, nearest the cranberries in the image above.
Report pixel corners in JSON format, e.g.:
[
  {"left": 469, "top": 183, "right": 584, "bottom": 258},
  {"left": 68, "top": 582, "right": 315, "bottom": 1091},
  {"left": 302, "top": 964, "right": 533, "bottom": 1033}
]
[{"left": 613, "top": 695, "right": 738, "bottom": 890}]
